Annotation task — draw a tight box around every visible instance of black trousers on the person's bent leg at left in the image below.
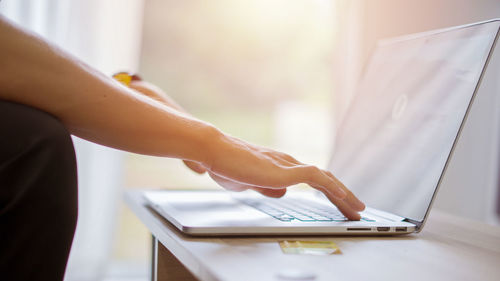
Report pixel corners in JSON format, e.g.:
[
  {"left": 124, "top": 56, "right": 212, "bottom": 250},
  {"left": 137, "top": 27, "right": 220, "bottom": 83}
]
[{"left": 0, "top": 100, "right": 78, "bottom": 281}]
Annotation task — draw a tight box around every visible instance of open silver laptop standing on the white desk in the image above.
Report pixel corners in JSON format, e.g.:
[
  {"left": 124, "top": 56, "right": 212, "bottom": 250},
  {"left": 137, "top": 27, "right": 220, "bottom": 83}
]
[{"left": 144, "top": 19, "right": 500, "bottom": 236}]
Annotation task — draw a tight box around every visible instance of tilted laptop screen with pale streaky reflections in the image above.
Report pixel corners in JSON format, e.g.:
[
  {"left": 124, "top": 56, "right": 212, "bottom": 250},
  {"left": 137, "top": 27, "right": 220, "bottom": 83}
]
[{"left": 329, "top": 21, "right": 500, "bottom": 221}]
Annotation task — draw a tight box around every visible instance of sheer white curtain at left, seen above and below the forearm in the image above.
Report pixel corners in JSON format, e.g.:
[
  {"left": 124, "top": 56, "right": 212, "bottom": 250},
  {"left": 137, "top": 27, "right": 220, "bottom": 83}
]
[{"left": 0, "top": 0, "right": 143, "bottom": 280}]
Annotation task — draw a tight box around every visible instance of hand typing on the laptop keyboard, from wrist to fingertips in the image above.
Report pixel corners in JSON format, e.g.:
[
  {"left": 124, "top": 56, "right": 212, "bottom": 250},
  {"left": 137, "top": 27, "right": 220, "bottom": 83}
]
[{"left": 205, "top": 134, "right": 365, "bottom": 220}]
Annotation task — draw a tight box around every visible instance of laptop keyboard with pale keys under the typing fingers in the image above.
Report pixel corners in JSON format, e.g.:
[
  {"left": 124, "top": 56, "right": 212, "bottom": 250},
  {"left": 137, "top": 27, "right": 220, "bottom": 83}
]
[{"left": 240, "top": 198, "right": 374, "bottom": 222}]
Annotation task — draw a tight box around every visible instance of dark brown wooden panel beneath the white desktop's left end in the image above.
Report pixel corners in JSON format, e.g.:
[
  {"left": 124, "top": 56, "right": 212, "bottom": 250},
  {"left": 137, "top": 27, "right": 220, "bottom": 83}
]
[{"left": 151, "top": 236, "right": 197, "bottom": 281}]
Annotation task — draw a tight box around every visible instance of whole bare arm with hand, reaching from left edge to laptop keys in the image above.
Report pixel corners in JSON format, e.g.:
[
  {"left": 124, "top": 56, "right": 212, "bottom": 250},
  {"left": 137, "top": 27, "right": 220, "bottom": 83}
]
[{"left": 0, "top": 17, "right": 364, "bottom": 219}]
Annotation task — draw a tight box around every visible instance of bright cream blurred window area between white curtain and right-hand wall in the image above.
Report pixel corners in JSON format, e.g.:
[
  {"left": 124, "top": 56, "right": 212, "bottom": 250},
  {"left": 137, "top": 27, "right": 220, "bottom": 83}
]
[{"left": 118, "top": 0, "right": 337, "bottom": 276}]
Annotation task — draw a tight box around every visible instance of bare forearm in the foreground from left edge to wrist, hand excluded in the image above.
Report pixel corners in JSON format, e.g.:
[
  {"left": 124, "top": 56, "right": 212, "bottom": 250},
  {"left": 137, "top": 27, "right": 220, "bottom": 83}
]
[{"left": 0, "top": 15, "right": 218, "bottom": 162}]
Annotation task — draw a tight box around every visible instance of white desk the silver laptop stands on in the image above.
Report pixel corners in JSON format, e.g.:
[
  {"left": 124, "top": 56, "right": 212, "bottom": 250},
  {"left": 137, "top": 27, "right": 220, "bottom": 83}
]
[{"left": 126, "top": 192, "right": 500, "bottom": 281}]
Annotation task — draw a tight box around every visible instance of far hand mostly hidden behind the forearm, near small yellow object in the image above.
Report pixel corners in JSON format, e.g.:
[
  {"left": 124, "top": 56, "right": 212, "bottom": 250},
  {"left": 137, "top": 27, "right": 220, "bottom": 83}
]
[{"left": 129, "top": 81, "right": 206, "bottom": 174}]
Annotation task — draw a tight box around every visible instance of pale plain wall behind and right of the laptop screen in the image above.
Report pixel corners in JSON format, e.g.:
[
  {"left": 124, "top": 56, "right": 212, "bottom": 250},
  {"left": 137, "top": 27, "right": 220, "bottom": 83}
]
[{"left": 335, "top": 0, "right": 500, "bottom": 223}]
